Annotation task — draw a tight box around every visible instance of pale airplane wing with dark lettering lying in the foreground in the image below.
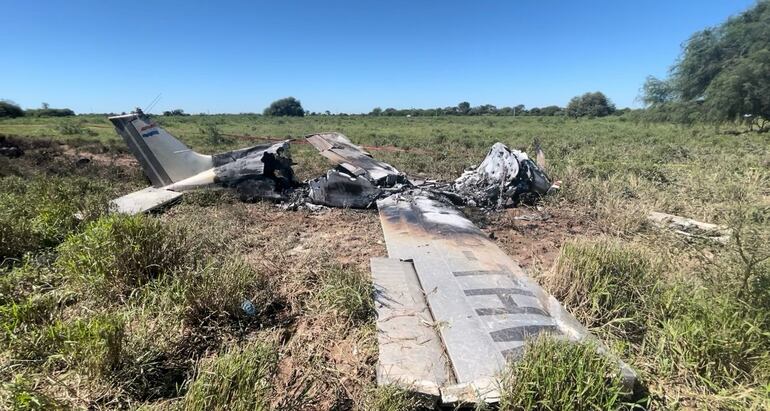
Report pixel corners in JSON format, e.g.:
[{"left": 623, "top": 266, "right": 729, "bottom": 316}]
[{"left": 372, "top": 194, "right": 636, "bottom": 403}]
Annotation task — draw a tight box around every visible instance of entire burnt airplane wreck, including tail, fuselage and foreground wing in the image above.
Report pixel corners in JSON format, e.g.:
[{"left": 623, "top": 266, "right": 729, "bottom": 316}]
[{"left": 110, "top": 111, "right": 636, "bottom": 404}]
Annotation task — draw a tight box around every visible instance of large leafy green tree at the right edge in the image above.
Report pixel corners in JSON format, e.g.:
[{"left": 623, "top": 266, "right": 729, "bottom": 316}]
[{"left": 642, "top": 0, "right": 770, "bottom": 124}]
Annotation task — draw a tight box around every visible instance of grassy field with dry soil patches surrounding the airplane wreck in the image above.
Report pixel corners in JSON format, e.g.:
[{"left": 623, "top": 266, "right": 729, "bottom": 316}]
[{"left": 0, "top": 115, "right": 770, "bottom": 410}]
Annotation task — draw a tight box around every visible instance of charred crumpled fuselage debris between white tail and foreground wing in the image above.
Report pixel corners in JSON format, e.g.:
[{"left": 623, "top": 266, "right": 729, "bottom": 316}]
[{"left": 268, "top": 133, "right": 556, "bottom": 209}]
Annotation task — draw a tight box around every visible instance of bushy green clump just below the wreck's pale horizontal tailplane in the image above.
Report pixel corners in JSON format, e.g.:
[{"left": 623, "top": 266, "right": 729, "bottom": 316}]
[{"left": 56, "top": 214, "right": 201, "bottom": 300}]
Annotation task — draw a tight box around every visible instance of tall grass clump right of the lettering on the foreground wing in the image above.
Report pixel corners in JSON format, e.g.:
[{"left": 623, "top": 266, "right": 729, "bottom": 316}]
[{"left": 545, "top": 239, "right": 659, "bottom": 338}]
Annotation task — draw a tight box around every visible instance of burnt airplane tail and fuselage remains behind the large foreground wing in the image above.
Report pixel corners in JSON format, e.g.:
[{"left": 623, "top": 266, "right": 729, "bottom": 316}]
[{"left": 109, "top": 110, "right": 555, "bottom": 214}]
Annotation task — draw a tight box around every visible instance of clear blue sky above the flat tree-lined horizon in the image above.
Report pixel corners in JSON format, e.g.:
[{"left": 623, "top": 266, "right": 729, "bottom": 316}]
[{"left": 0, "top": 0, "right": 754, "bottom": 113}]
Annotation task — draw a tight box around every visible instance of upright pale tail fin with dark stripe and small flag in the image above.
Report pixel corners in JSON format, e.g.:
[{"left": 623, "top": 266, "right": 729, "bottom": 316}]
[{"left": 109, "top": 109, "right": 214, "bottom": 187}]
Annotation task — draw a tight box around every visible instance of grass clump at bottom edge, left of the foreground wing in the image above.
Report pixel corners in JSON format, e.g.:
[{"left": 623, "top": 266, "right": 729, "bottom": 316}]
[{"left": 183, "top": 341, "right": 278, "bottom": 411}]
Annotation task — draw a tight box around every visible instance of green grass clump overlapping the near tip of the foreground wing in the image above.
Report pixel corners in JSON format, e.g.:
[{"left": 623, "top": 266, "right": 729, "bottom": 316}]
[{"left": 500, "top": 337, "right": 624, "bottom": 410}]
